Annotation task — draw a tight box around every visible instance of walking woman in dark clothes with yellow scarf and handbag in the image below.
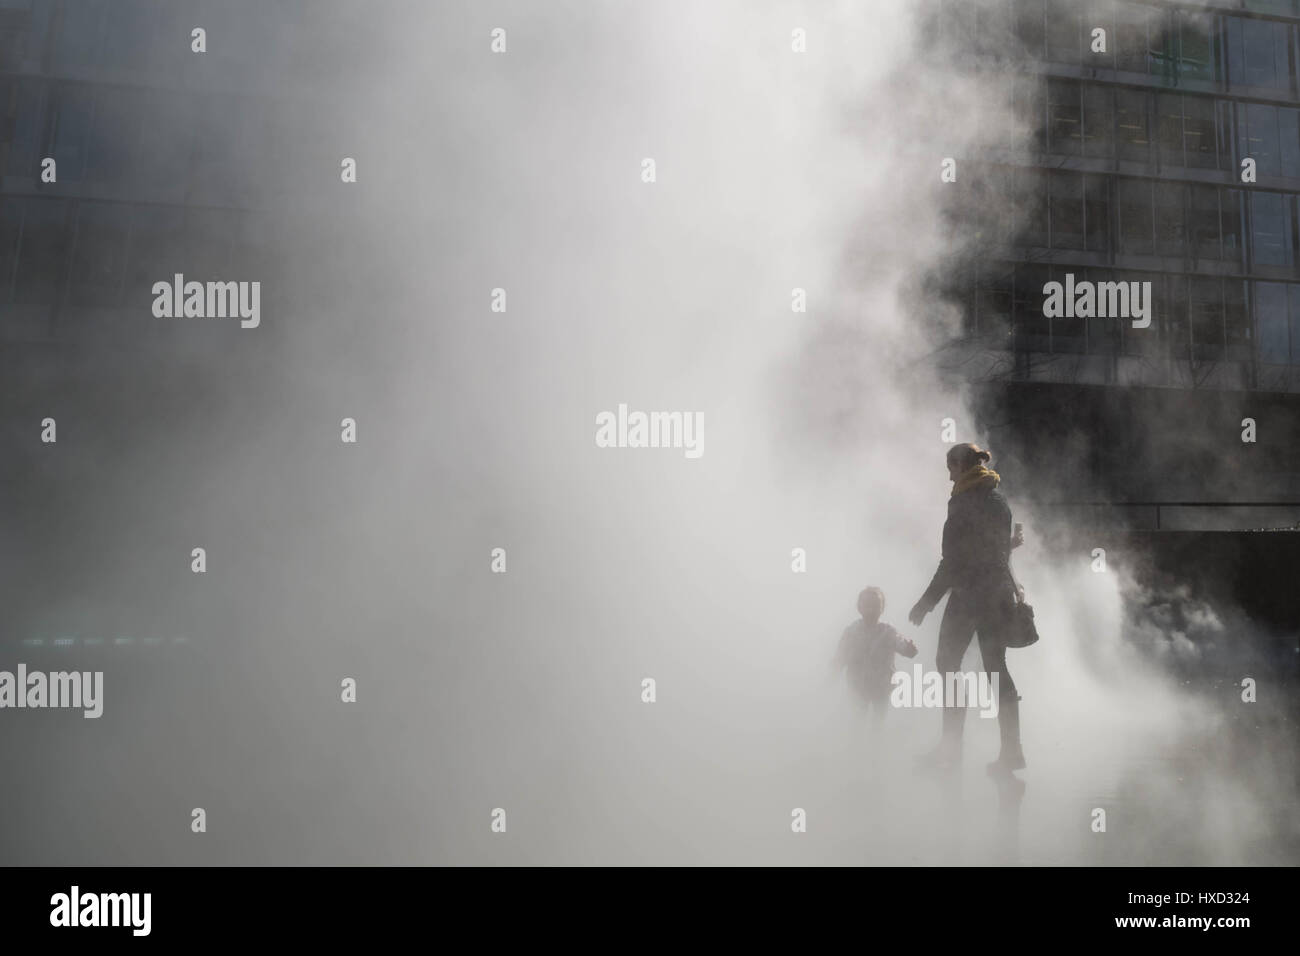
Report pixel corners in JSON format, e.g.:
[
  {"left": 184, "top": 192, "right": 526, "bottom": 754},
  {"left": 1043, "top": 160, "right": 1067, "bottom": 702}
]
[{"left": 907, "top": 445, "right": 1024, "bottom": 774}]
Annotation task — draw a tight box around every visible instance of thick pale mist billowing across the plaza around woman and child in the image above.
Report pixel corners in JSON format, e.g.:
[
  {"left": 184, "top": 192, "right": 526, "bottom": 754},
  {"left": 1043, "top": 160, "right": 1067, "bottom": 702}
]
[{"left": 4, "top": 0, "right": 1296, "bottom": 865}]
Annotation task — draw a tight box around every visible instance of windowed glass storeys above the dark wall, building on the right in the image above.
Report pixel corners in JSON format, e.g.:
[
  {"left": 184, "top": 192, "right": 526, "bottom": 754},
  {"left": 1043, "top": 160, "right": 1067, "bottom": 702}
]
[{"left": 950, "top": 0, "right": 1300, "bottom": 393}]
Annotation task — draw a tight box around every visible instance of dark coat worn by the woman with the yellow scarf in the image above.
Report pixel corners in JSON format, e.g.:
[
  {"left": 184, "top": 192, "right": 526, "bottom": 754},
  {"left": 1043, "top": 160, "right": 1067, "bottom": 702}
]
[{"left": 920, "top": 488, "right": 1014, "bottom": 613}]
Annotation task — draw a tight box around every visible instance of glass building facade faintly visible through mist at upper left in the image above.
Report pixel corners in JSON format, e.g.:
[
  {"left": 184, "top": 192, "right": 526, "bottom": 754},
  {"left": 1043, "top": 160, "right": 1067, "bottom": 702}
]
[{"left": 0, "top": 0, "right": 301, "bottom": 351}]
